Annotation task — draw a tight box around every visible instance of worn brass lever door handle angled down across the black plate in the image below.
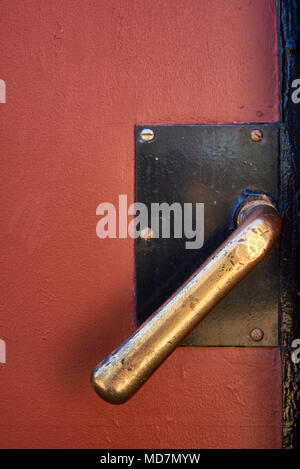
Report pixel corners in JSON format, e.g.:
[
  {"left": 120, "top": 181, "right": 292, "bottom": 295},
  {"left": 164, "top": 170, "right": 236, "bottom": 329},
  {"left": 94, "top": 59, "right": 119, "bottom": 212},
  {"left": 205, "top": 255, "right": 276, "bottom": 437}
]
[{"left": 91, "top": 195, "right": 281, "bottom": 404}]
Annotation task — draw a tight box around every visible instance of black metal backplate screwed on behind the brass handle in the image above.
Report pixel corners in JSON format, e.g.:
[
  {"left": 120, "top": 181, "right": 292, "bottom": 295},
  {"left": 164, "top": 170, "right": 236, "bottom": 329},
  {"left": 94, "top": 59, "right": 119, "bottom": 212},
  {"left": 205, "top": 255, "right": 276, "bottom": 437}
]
[{"left": 135, "top": 124, "right": 279, "bottom": 346}]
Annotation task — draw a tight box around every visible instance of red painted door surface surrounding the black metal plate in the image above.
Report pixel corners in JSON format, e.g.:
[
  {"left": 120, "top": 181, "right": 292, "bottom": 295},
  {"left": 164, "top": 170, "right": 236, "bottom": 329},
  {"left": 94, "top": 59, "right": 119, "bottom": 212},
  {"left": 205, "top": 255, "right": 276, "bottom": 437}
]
[{"left": 0, "top": 0, "right": 281, "bottom": 448}]
